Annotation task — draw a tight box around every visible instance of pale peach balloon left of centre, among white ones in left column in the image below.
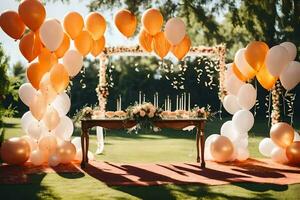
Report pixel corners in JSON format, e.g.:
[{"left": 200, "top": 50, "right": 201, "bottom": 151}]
[{"left": 29, "top": 91, "right": 47, "bottom": 120}]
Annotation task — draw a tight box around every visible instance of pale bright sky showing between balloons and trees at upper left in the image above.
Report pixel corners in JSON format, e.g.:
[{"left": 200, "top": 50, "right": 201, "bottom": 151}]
[{"left": 0, "top": 0, "right": 138, "bottom": 66}]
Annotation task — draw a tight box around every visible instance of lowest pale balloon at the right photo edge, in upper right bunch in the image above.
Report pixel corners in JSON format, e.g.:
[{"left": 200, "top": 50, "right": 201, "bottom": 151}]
[{"left": 279, "top": 61, "right": 300, "bottom": 90}]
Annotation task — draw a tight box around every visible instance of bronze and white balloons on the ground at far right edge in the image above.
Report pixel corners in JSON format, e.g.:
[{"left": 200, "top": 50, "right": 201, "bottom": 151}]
[{"left": 259, "top": 122, "right": 300, "bottom": 165}]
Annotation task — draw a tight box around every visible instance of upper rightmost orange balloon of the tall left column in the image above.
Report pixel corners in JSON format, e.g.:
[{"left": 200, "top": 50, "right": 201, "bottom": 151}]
[{"left": 85, "top": 12, "right": 106, "bottom": 40}]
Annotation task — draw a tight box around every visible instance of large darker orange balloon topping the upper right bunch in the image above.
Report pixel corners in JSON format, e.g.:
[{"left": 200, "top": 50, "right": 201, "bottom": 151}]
[{"left": 245, "top": 41, "right": 269, "bottom": 71}]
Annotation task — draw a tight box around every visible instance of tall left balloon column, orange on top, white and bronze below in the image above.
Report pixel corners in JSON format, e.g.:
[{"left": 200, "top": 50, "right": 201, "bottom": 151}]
[{"left": 0, "top": 0, "right": 102, "bottom": 166}]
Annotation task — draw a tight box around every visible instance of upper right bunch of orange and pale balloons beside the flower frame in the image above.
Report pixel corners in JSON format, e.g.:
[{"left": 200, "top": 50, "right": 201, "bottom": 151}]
[{"left": 233, "top": 41, "right": 300, "bottom": 91}]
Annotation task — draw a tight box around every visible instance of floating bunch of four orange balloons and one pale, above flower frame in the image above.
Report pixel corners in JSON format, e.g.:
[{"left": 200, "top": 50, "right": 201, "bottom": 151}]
[{"left": 139, "top": 8, "right": 191, "bottom": 60}]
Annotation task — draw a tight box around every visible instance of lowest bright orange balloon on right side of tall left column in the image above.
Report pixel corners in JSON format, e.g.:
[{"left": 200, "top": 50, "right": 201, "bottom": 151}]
[{"left": 50, "top": 64, "right": 70, "bottom": 93}]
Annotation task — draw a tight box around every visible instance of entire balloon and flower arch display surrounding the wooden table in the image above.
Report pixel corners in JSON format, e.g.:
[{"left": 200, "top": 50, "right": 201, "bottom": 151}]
[{"left": 0, "top": 0, "right": 300, "bottom": 166}]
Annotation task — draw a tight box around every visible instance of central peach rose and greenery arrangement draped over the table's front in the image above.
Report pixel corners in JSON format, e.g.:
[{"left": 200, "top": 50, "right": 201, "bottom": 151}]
[{"left": 126, "top": 103, "right": 161, "bottom": 131}]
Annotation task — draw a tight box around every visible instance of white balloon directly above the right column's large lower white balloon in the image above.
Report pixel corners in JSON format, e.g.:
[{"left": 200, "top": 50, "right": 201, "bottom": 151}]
[{"left": 237, "top": 83, "right": 257, "bottom": 110}]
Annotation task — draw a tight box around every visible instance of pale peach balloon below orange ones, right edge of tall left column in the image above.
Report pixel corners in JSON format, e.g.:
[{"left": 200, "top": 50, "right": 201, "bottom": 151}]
[{"left": 63, "top": 50, "right": 83, "bottom": 77}]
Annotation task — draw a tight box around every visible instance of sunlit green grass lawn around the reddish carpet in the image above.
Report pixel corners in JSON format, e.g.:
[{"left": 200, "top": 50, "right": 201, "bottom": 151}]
[{"left": 0, "top": 118, "right": 300, "bottom": 199}]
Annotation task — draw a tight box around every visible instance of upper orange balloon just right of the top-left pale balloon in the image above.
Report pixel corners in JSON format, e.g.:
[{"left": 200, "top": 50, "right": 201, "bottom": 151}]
[{"left": 64, "top": 12, "right": 84, "bottom": 40}]
